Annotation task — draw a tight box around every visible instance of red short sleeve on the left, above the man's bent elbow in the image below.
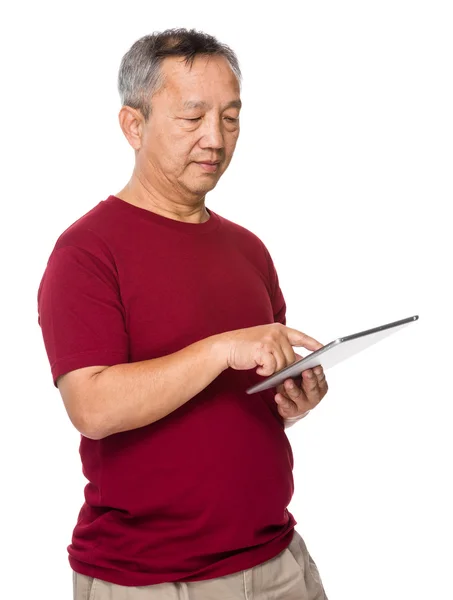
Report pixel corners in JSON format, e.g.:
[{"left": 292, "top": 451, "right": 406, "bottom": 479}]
[{"left": 38, "top": 246, "right": 129, "bottom": 387}]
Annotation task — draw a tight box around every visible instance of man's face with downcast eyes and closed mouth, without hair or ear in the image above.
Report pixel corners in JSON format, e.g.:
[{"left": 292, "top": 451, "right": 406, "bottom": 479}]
[{"left": 137, "top": 55, "right": 240, "bottom": 197}]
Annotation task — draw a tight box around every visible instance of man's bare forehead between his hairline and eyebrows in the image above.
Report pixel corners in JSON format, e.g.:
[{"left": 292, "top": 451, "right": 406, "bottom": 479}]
[{"left": 161, "top": 55, "right": 240, "bottom": 108}]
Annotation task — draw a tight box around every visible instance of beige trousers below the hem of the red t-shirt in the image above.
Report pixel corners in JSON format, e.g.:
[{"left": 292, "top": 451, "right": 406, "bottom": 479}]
[{"left": 74, "top": 531, "right": 327, "bottom": 600}]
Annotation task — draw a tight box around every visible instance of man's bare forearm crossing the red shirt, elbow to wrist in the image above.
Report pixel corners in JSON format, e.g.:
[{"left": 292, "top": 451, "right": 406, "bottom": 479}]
[{"left": 87, "top": 335, "right": 227, "bottom": 439}]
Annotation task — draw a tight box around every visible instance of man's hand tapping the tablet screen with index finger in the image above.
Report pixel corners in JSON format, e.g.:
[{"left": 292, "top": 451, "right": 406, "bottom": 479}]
[{"left": 219, "top": 323, "right": 323, "bottom": 376}]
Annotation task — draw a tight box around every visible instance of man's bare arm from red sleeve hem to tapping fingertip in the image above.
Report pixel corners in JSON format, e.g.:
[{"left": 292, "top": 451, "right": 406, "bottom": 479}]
[{"left": 57, "top": 323, "right": 321, "bottom": 439}]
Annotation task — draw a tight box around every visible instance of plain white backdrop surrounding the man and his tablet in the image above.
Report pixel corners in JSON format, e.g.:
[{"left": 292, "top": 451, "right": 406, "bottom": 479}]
[{"left": 0, "top": 0, "right": 453, "bottom": 600}]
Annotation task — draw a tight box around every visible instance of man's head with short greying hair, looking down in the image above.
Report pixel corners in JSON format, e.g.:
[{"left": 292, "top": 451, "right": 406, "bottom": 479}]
[{"left": 118, "top": 29, "right": 241, "bottom": 199}]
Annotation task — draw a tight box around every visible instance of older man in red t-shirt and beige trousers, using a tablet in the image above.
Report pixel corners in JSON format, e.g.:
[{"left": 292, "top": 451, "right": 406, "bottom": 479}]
[{"left": 38, "top": 29, "right": 327, "bottom": 600}]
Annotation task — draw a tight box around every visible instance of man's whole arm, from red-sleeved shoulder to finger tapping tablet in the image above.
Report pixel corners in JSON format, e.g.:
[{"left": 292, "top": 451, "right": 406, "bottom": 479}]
[{"left": 38, "top": 246, "right": 321, "bottom": 439}]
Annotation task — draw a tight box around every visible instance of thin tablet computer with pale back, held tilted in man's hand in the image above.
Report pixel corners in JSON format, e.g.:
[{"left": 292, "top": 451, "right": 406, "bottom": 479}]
[{"left": 246, "top": 315, "right": 418, "bottom": 394}]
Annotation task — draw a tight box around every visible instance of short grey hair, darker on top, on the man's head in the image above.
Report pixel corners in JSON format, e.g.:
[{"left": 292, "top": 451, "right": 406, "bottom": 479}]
[{"left": 118, "top": 29, "right": 242, "bottom": 121}]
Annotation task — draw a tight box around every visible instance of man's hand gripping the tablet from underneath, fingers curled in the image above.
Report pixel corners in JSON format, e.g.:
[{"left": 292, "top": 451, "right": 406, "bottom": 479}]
[{"left": 274, "top": 366, "right": 328, "bottom": 419}]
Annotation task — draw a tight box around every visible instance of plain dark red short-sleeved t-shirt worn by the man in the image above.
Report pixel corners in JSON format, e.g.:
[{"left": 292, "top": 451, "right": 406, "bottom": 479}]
[{"left": 38, "top": 196, "right": 297, "bottom": 586}]
